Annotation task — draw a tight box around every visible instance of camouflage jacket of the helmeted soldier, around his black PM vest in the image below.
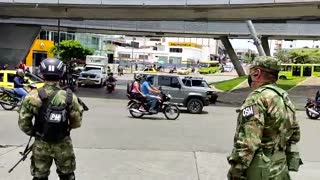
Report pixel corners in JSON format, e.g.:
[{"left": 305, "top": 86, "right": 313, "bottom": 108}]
[{"left": 18, "top": 82, "right": 83, "bottom": 135}]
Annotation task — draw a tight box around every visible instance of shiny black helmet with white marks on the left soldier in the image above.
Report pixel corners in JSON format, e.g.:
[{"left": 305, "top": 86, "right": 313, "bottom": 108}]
[{"left": 40, "top": 58, "right": 65, "bottom": 80}]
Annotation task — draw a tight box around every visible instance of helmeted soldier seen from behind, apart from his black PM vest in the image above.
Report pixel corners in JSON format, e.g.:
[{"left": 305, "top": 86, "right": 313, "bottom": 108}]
[{"left": 19, "top": 59, "right": 83, "bottom": 180}]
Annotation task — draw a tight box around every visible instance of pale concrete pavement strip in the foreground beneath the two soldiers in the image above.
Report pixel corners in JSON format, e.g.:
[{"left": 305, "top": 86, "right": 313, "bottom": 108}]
[{"left": 0, "top": 147, "right": 320, "bottom": 180}]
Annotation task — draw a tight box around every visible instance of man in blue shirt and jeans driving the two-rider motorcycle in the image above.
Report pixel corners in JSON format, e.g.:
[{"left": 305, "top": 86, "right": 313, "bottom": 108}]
[{"left": 141, "top": 76, "right": 160, "bottom": 114}]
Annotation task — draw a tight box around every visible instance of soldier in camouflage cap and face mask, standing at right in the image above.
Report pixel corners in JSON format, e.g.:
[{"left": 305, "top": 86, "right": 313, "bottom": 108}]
[{"left": 227, "top": 57, "right": 302, "bottom": 180}]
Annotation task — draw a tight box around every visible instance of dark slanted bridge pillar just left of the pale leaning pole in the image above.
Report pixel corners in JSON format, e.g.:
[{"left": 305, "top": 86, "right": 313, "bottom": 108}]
[{"left": 220, "top": 36, "right": 246, "bottom": 76}]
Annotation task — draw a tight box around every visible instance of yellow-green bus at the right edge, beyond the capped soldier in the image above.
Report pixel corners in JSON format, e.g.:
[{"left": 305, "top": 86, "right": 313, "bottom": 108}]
[{"left": 279, "top": 64, "right": 320, "bottom": 79}]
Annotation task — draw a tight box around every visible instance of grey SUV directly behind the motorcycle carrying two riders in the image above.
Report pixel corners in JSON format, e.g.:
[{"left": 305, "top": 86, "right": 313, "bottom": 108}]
[{"left": 136, "top": 73, "right": 214, "bottom": 114}]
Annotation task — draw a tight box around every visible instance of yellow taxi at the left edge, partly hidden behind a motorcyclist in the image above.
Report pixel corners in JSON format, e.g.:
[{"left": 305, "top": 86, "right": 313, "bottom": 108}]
[{"left": 0, "top": 70, "right": 44, "bottom": 89}]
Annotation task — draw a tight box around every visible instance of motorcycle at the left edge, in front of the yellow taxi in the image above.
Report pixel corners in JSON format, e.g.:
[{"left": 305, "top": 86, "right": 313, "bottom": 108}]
[{"left": 0, "top": 84, "right": 37, "bottom": 111}]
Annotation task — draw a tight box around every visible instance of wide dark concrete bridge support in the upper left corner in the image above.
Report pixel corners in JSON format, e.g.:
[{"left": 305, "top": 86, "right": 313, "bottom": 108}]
[{"left": 0, "top": 24, "right": 41, "bottom": 67}]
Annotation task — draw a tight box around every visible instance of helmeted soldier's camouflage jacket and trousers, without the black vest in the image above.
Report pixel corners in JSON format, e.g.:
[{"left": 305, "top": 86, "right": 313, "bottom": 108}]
[{"left": 19, "top": 82, "right": 83, "bottom": 179}]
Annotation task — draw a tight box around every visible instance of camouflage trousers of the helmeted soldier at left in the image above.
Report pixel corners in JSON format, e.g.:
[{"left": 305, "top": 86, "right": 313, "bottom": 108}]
[{"left": 30, "top": 136, "right": 76, "bottom": 178}]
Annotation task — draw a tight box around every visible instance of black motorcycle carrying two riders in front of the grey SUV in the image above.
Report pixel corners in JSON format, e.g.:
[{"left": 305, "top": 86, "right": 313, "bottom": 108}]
[{"left": 127, "top": 88, "right": 180, "bottom": 120}]
